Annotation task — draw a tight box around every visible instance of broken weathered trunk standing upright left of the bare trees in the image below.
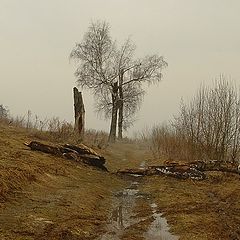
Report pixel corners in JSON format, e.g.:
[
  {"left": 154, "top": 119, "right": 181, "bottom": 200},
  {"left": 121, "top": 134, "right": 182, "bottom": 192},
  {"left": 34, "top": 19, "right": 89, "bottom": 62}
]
[{"left": 73, "top": 87, "right": 85, "bottom": 139}]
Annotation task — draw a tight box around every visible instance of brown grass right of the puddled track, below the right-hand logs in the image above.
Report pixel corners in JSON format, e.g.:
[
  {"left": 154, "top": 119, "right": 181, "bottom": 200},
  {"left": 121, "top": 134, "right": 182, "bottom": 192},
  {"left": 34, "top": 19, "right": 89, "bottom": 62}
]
[{"left": 143, "top": 172, "right": 240, "bottom": 240}]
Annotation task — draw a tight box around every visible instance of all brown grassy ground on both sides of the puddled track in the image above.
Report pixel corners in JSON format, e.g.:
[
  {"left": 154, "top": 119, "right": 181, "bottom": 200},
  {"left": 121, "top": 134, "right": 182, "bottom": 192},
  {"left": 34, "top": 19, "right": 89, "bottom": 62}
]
[{"left": 0, "top": 125, "right": 240, "bottom": 240}]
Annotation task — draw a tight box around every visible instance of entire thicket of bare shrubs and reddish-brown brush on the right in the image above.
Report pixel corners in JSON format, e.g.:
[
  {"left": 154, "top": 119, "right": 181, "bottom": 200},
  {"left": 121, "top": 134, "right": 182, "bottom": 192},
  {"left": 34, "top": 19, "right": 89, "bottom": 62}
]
[{"left": 148, "top": 76, "right": 240, "bottom": 162}]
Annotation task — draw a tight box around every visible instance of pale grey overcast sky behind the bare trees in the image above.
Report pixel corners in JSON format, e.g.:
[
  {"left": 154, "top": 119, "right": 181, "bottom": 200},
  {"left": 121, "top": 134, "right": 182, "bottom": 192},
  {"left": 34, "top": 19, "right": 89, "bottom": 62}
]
[{"left": 0, "top": 0, "right": 240, "bottom": 132}]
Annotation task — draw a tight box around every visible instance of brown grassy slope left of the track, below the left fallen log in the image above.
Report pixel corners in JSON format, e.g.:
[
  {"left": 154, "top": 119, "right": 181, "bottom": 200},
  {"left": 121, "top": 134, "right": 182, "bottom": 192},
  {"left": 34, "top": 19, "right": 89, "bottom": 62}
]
[{"left": 0, "top": 125, "right": 124, "bottom": 239}]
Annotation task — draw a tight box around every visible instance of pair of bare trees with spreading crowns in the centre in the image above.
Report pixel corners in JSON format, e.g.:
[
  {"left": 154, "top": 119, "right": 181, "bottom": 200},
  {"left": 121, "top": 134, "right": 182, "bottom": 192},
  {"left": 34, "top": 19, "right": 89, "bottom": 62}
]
[{"left": 70, "top": 21, "right": 167, "bottom": 141}]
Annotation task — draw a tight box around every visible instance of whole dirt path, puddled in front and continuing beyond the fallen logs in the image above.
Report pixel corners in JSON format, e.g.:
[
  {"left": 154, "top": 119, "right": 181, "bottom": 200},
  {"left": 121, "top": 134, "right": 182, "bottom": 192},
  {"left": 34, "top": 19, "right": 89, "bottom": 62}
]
[{"left": 98, "top": 144, "right": 178, "bottom": 240}]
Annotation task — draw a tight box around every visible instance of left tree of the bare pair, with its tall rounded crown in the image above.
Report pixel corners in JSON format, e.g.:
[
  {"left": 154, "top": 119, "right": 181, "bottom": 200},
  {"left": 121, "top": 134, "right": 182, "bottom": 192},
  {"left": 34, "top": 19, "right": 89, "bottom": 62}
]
[{"left": 70, "top": 21, "right": 118, "bottom": 142}]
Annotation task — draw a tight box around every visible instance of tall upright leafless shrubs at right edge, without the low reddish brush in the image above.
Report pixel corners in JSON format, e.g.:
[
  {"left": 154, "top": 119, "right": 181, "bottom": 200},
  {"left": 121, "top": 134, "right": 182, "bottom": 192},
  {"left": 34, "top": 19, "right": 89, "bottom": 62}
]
[{"left": 175, "top": 76, "right": 240, "bottom": 161}]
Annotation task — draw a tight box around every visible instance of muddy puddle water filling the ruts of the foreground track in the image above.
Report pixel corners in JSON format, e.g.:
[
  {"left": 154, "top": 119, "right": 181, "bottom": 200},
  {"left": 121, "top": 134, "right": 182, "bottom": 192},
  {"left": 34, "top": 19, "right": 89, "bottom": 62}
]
[{"left": 99, "top": 167, "right": 178, "bottom": 240}]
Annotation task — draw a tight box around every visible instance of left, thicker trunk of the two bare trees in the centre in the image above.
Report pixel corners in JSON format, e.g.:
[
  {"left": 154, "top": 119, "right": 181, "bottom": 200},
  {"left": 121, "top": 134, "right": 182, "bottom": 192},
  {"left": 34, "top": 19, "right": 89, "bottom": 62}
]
[{"left": 108, "top": 83, "right": 118, "bottom": 142}]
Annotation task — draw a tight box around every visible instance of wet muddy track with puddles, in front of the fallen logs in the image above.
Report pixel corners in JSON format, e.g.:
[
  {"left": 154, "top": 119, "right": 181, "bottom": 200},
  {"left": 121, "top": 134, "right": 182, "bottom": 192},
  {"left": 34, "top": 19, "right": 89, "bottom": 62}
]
[{"left": 97, "top": 161, "right": 179, "bottom": 240}]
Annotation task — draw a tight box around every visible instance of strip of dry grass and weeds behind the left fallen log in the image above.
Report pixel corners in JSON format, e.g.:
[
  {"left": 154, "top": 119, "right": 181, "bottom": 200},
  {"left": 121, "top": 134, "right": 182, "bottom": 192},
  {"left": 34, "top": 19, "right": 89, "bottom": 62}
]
[{"left": 0, "top": 111, "right": 108, "bottom": 149}]
